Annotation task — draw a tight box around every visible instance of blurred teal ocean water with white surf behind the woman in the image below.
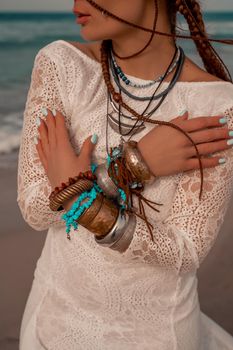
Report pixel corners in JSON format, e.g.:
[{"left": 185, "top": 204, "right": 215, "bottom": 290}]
[{"left": 0, "top": 12, "right": 233, "bottom": 162}]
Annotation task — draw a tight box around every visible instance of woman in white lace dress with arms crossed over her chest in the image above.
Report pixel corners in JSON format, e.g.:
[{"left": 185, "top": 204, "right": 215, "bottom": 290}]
[{"left": 17, "top": 0, "right": 233, "bottom": 350}]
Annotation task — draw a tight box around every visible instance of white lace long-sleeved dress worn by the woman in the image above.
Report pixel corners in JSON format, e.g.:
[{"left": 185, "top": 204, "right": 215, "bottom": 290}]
[{"left": 17, "top": 40, "right": 233, "bottom": 350}]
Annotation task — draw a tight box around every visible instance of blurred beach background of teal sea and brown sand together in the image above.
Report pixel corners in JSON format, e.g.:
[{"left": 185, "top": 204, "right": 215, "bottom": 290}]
[{"left": 0, "top": 13, "right": 233, "bottom": 350}]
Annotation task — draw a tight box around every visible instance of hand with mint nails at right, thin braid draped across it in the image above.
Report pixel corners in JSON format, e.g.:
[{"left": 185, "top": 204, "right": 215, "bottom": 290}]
[{"left": 138, "top": 112, "right": 231, "bottom": 176}]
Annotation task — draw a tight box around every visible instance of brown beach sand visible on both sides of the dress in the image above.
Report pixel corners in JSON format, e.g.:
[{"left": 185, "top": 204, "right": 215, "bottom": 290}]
[{"left": 0, "top": 154, "right": 233, "bottom": 350}]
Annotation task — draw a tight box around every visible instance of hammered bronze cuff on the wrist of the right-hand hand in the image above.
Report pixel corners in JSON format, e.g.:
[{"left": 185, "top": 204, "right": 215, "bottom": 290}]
[{"left": 123, "top": 140, "right": 155, "bottom": 184}]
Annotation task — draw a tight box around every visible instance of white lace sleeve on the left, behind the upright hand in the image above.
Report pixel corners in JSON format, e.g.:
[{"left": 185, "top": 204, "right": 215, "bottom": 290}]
[{"left": 17, "top": 49, "right": 65, "bottom": 231}]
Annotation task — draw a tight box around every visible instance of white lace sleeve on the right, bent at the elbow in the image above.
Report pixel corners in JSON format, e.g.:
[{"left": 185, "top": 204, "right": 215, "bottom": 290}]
[{"left": 122, "top": 108, "right": 233, "bottom": 272}]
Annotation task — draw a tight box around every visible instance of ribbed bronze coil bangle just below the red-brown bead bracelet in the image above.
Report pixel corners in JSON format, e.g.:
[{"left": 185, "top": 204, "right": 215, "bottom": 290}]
[{"left": 49, "top": 179, "right": 93, "bottom": 211}]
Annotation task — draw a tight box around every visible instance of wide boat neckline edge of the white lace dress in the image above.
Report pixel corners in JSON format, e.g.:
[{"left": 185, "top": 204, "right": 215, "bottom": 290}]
[{"left": 57, "top": 39, "right": 233, "bottom": 86}]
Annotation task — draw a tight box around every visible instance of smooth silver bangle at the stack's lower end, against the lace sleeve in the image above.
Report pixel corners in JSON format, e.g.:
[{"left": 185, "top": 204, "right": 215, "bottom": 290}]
[{"left": 95, "top": 211, "right": 136, "bottom": 252}]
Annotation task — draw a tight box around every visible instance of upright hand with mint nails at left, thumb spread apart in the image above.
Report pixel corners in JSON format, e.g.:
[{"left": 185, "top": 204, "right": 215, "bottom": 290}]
[{"left": 36, "top": 109, "right": 95, "bottom": 188}]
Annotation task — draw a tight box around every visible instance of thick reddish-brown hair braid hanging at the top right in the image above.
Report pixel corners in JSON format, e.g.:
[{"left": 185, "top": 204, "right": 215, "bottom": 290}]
[{"left": 175, "top": 0, "right": 231, "bottom": 81}]
